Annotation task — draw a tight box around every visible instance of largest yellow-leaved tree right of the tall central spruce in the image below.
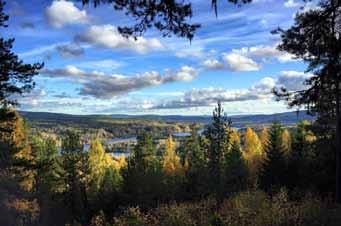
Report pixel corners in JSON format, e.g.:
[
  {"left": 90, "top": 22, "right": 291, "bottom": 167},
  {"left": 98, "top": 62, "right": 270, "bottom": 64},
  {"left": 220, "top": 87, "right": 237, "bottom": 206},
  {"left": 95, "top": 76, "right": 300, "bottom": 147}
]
[{"left": 243, "top": 128, "right": 264, "bottom": 186}]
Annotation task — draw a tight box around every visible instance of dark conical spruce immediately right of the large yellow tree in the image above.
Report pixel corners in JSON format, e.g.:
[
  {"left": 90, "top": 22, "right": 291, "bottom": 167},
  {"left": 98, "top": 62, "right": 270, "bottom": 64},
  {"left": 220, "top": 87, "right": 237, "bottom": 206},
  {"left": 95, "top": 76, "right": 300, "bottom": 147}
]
[{"left": 260, "top": 122, "right": 286, "bottom": 192}]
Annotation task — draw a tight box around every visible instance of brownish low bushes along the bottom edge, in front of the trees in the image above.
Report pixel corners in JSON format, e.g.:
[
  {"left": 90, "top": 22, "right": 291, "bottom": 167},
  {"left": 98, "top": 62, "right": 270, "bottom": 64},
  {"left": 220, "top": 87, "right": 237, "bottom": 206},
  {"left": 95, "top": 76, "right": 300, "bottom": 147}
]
[{"left": 93, "top": 189, "right": 333, "bottom": 226}]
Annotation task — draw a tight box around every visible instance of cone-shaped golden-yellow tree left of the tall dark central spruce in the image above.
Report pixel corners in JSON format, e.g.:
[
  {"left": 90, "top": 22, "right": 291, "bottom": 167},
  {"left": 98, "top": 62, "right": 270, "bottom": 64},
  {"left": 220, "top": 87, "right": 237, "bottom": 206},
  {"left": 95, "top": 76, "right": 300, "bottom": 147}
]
[{"left": 163, "top": 136, "right": 183, "bottom": 175}]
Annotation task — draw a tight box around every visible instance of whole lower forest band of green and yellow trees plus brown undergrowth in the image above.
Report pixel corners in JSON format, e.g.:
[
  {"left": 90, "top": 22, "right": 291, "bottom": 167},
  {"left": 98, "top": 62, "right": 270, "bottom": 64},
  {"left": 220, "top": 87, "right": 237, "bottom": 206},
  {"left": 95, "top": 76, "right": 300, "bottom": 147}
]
[{"left": 0, "top": 103, "right": 340, "bottom": 226}]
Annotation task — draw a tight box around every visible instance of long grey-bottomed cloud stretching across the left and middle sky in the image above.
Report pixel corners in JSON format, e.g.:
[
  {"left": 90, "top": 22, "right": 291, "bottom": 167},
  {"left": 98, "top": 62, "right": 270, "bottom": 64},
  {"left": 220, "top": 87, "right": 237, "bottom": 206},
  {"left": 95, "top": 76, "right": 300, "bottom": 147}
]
[{"left": 42, "top": 66, "right": 198, "bottom": 99}]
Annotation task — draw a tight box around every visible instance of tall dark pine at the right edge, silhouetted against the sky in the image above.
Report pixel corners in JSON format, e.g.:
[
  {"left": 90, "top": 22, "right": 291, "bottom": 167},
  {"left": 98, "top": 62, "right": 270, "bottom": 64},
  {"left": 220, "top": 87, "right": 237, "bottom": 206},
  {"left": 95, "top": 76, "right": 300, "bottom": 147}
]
[{"left": 274, "top": 0, "right": 341, "bottom": 203}]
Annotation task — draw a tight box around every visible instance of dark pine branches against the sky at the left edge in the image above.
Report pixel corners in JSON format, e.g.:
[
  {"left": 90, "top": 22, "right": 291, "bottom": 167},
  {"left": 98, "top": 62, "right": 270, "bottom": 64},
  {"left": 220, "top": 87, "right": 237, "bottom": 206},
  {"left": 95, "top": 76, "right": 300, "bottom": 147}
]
[{"left": 0, "top": 0, "right": 43, "bottom": 107}]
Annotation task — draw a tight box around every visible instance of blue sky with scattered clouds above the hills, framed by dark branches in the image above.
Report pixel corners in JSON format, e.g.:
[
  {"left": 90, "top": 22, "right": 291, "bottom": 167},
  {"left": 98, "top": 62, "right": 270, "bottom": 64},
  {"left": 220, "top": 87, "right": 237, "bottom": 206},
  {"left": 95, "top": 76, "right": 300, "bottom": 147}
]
[{"left": 1, "top": 0, "right": 314, "bottom": 115}]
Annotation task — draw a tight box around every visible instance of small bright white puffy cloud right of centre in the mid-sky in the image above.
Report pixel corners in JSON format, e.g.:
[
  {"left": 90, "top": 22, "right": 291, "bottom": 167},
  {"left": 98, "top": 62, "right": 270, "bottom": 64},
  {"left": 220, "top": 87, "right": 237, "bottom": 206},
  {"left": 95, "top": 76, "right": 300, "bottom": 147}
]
[{"left": 223, "top": 52, "right": 260, "bottom": 71}]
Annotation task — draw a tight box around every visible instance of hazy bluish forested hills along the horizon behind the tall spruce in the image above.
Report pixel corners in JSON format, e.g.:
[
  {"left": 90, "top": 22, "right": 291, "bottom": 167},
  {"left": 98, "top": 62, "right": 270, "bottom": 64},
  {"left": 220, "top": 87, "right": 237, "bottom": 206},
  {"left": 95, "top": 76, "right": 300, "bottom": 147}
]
[{"left": 20, "top": 111, "right": 315, "bottom": 128}]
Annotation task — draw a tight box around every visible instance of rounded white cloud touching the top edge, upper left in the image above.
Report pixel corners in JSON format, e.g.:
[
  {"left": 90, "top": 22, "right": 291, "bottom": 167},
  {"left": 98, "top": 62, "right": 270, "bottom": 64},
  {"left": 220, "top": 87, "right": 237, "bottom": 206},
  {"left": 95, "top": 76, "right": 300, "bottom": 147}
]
[{"left": 45, "top": 0, "right": 89, "bottom": 28}]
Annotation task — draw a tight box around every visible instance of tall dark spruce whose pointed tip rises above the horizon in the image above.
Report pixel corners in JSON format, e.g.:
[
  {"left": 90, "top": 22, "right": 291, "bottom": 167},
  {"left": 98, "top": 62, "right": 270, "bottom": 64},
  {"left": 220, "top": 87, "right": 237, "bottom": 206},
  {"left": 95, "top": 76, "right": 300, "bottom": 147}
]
[{"left": 205, "top": 102, "right": 231, "bottom": 199}]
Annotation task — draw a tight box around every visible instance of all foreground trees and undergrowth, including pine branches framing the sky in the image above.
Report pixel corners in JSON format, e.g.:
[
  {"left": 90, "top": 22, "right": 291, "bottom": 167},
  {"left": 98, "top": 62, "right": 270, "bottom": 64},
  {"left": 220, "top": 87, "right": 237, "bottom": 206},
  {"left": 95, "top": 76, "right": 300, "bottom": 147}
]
[{"left": 0, "top": 0, "right": 341, "bottom": 226}]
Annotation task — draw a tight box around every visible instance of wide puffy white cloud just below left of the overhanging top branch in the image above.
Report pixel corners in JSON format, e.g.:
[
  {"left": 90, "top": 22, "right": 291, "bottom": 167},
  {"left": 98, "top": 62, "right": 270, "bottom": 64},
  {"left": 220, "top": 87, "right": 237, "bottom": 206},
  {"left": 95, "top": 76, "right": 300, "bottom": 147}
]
[{"left": 75, "top": 25, "right": 164, "bottom": 53}]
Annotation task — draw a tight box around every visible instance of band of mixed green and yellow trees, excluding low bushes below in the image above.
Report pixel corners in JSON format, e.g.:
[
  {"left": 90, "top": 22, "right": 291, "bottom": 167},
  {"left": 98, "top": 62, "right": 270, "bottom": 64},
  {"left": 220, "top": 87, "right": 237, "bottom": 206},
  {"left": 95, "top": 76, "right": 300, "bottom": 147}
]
[{"left": 0, "top": 103, "right": 335, "bottom": 225}]
